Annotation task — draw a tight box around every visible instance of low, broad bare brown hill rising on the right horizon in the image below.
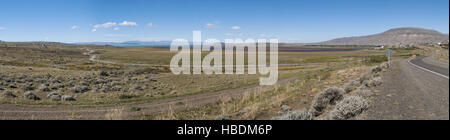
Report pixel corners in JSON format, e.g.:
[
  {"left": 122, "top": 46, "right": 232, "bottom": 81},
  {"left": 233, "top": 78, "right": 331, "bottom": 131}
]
[{"left": 317, "top": 28, "right": 449, "bottom": 45}]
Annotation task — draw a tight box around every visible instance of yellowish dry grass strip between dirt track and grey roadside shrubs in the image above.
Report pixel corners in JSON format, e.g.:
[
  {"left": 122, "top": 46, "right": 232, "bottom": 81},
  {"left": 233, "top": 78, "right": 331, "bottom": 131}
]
[{"left": 144, "top": 60, "right": 370, "bottom": 120}]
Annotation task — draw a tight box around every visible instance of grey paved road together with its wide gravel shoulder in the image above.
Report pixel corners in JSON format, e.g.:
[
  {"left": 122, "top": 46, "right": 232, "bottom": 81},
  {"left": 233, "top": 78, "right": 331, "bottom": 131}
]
[{"left": 363, "top": 57, "right": 449, "bottom": 120}]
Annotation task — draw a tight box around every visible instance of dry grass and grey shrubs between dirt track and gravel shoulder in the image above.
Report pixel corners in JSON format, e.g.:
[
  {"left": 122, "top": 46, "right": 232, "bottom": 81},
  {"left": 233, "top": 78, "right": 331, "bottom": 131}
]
[{"left": 147, "top": 60, "right": 394, "bottom": 120}]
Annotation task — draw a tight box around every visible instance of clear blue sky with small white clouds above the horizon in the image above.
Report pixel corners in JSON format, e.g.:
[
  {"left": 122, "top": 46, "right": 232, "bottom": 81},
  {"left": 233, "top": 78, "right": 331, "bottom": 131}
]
[{"left": 0, "top": 0, "right": 449, "bottom": 42}]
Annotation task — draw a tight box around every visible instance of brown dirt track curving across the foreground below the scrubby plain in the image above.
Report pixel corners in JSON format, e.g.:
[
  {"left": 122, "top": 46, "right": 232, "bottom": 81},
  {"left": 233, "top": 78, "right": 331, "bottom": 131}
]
[{"left": 0, "top": 77, "right": 296, "bottom": 120}]
